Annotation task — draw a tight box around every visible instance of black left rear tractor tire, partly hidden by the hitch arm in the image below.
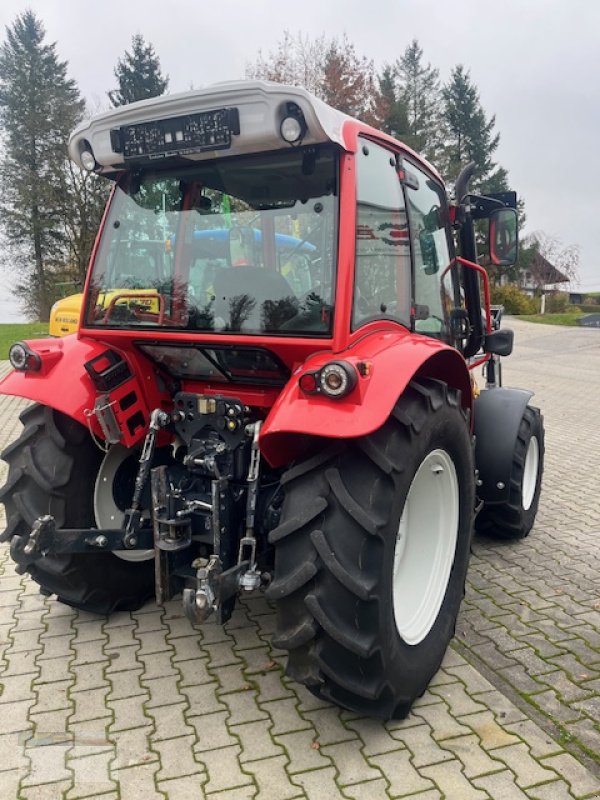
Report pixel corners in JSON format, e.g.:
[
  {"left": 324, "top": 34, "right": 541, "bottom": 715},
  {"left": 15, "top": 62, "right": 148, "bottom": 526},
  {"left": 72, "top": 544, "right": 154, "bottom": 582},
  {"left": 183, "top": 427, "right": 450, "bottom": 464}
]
[{"left": 0, "top": 404, "right": 154, "bottom": 614}]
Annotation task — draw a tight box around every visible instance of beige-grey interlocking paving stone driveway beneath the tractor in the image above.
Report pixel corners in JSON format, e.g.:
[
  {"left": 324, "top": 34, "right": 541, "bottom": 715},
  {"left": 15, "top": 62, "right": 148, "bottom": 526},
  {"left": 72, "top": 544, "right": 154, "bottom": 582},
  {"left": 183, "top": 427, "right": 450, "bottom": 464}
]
[{"left": 0, "top": 321, "right": 600, "bottom": 800}]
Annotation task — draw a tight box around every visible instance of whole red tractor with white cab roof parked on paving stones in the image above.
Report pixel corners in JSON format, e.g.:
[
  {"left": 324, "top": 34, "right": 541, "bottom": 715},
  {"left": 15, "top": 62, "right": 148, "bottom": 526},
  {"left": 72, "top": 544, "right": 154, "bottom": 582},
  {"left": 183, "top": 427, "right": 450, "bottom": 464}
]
[{"left": 1, "top": 82, "right": 544, "bottom": 718}]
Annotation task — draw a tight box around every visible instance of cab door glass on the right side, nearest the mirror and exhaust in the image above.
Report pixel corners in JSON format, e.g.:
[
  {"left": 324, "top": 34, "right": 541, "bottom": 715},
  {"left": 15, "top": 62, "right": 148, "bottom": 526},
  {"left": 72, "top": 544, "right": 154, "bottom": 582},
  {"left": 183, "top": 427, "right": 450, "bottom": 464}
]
[{"left": 406, "top": 163, "right": 457, "bottom": 341}]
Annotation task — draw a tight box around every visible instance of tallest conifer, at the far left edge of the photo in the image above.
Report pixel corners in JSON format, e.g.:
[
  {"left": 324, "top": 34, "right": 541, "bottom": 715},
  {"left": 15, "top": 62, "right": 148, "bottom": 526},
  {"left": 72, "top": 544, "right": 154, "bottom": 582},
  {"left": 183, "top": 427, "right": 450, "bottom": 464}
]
[{"left": 0, "top": 11, "right": 84, "bottom": 320}]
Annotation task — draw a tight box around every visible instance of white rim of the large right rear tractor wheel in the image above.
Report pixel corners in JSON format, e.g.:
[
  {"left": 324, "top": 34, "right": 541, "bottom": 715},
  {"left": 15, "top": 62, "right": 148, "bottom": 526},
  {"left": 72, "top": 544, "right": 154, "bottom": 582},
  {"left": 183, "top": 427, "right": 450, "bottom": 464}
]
[{"left": 393, "top": 450, "right": 460, "bottom": 645}]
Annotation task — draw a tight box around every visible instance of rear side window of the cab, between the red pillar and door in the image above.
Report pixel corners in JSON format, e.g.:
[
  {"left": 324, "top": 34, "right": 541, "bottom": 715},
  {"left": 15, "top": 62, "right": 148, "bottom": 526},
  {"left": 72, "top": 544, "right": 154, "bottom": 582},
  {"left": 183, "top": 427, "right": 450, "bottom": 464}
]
[{"left": 352, "top": 140, "right": 410, "bottom": 330}]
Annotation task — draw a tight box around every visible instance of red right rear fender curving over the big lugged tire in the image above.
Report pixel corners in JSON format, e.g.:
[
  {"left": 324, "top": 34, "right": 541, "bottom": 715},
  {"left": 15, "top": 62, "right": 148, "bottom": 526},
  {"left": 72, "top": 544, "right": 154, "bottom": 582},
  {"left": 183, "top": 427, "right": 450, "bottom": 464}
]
[{"left": 260, "top": 330, "right": 472, "bottom": 467}]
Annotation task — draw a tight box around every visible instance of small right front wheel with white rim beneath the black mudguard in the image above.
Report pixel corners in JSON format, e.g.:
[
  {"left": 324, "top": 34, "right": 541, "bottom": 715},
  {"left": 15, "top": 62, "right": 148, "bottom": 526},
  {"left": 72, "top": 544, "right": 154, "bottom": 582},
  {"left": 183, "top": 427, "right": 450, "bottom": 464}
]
[{"left": 475, "top": 406, "right": 544, "bottom": 539}]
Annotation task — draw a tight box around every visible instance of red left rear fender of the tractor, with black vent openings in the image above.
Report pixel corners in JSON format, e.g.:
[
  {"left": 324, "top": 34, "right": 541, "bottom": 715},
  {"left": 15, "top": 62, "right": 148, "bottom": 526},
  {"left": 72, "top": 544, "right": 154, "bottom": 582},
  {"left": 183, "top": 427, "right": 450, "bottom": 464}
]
[{"left": 0, "top": 334, "right": 149, "bottom": 447}]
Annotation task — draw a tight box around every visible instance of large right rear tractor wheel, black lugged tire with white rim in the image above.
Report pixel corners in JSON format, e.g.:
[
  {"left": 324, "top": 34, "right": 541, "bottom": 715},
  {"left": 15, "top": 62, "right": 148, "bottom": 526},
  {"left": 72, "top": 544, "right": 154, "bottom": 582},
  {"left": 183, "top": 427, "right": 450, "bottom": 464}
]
[{"left": 268, "top": 379, "right": 474, "bottom": 719}]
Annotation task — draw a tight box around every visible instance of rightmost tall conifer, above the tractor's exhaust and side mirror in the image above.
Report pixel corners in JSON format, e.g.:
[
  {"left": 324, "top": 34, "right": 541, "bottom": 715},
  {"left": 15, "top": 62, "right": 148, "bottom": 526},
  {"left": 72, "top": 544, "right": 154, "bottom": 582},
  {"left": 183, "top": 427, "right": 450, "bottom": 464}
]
[{"left": 442, "top": 64, "right": 508, "bottom": 192}]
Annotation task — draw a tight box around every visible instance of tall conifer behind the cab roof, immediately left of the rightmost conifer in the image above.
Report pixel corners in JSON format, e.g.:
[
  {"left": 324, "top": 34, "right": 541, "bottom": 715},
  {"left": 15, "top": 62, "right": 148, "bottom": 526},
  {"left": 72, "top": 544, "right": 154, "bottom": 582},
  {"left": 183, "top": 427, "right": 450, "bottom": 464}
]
[{"left": 395, "top": 39, "right": 442, "bottom": 162}]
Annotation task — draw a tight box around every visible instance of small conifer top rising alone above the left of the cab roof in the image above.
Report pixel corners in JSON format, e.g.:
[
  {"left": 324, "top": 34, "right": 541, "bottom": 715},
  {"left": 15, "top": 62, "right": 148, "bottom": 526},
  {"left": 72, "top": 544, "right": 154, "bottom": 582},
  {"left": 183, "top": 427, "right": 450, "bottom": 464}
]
[{"left": 108, "top": 33, "right": 169, "bottom": 107}]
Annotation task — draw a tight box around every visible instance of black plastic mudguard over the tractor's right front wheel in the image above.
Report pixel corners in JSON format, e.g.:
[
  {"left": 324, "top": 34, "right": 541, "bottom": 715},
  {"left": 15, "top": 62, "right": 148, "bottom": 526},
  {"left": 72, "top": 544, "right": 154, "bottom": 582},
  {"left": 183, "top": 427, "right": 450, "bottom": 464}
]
[{"left": 473, "top": 387, "right": 533, "bottom": 503}]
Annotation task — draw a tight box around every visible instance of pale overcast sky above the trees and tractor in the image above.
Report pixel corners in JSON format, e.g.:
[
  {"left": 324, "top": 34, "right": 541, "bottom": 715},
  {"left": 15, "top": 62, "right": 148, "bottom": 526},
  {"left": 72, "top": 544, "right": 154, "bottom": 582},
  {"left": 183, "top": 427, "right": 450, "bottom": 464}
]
[{"left": 0, "top": 0, "right": 600, "bottom": 322}]
